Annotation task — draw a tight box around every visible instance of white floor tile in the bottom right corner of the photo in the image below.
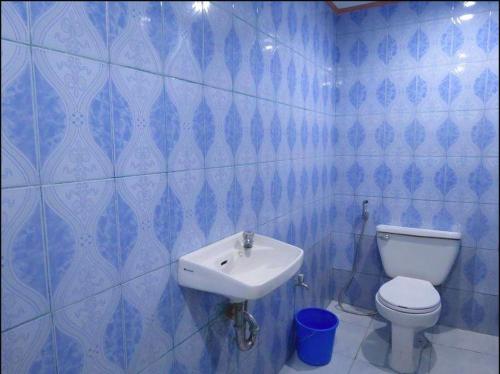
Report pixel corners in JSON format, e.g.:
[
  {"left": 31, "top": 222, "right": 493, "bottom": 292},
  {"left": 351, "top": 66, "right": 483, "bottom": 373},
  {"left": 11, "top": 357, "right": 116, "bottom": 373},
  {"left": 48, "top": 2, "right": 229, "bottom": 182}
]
[{"left": 429, "top": 344, "right": 498, "bottom": 374}]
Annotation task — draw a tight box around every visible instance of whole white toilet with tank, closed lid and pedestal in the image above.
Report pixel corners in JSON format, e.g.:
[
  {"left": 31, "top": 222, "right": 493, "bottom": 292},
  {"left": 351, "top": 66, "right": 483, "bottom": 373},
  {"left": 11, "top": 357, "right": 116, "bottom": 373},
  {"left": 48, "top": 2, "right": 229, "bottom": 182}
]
[{"left": 375, "top": 225, "right": 461, "bottom": 373}]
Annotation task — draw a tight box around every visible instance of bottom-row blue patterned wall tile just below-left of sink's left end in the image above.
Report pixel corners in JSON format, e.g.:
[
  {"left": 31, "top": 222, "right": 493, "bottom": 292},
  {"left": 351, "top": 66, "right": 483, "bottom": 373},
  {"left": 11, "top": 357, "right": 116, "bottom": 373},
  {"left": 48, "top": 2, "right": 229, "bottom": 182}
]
[{"left": 122, "top": 266, "right": 174, "bottom": 372}]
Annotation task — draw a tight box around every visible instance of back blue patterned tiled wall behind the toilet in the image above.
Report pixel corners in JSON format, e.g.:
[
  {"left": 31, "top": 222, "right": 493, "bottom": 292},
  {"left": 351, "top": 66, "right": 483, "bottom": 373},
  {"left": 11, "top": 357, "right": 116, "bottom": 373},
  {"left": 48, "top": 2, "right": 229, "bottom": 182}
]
[{"left": 333, "top": 1, "right": 499, "bottom": 335}]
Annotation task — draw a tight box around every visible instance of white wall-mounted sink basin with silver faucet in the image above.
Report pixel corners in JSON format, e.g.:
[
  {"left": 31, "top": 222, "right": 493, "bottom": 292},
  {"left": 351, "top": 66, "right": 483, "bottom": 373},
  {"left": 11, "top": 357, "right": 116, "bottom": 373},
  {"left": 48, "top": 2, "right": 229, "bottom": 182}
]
[{"left": 178, "top": 232, "right": 304, "bottom": 302}]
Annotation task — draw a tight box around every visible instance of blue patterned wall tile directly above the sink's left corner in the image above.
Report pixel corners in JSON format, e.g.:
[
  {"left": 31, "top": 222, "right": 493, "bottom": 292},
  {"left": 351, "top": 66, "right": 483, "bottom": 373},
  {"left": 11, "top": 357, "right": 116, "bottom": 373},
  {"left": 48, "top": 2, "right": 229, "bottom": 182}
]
[{"left": 168, "top": 170, "right": 205, "bottom": 260}]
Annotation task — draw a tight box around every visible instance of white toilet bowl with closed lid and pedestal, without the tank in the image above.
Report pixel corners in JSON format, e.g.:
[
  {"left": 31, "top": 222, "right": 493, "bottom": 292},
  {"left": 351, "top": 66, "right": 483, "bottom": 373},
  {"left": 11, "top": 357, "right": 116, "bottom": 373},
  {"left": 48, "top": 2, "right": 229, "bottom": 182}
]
[{"left": 375, "top": 276, "right": 441, "bottom": 373}]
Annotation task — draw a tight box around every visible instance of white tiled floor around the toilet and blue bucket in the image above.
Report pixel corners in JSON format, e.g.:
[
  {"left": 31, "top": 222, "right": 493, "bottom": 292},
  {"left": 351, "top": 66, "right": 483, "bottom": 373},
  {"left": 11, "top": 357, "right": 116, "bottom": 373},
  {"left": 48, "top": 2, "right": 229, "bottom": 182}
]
[{"left": 280, "top": 301, "right": 499, "bottom": 374}]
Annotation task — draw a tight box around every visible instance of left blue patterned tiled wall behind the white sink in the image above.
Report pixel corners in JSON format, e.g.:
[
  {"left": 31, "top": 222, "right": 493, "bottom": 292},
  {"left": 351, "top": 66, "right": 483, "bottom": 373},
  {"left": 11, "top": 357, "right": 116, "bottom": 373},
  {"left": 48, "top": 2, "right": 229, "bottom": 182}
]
[{"left": 2, "top": 2, "right": 336, "bottom": 374}]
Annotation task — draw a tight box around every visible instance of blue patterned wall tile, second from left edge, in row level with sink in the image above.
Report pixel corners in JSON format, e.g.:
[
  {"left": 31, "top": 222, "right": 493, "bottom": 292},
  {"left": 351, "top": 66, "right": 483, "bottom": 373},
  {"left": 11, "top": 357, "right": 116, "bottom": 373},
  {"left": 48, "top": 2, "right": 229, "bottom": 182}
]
[{"left": 42, "top": 180, "right": 119, "bottom": 308}]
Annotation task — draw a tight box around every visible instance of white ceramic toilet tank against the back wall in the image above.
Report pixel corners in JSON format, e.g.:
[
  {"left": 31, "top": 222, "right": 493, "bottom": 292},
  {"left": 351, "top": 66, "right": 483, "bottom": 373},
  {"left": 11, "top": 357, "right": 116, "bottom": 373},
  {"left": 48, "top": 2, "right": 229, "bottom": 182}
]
[{"left": 377, "top": 225, "right": 461, "bottom": 286}]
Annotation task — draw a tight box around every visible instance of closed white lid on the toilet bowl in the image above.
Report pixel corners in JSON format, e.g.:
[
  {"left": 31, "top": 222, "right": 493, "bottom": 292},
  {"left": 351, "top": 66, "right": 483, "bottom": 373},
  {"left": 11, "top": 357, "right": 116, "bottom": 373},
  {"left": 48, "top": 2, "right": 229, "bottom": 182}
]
[{"left": 378, "top": 276, "right": 441, "bottom": 313}]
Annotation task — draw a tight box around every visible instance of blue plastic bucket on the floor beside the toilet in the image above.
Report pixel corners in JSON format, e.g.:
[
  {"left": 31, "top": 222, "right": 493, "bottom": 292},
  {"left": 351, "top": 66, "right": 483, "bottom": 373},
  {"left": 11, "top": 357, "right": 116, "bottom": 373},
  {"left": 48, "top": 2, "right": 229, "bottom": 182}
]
[{"left": 295, "top": 308, "right": 339, "bottom": 366}]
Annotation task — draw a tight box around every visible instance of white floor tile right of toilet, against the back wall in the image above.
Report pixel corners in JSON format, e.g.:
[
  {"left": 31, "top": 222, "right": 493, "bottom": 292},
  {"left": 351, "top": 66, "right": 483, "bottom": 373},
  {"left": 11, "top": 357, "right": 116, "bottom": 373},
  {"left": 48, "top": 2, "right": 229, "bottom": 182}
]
[{"left": 431, "top": 325, "right": 498, "bottom": 356}]
